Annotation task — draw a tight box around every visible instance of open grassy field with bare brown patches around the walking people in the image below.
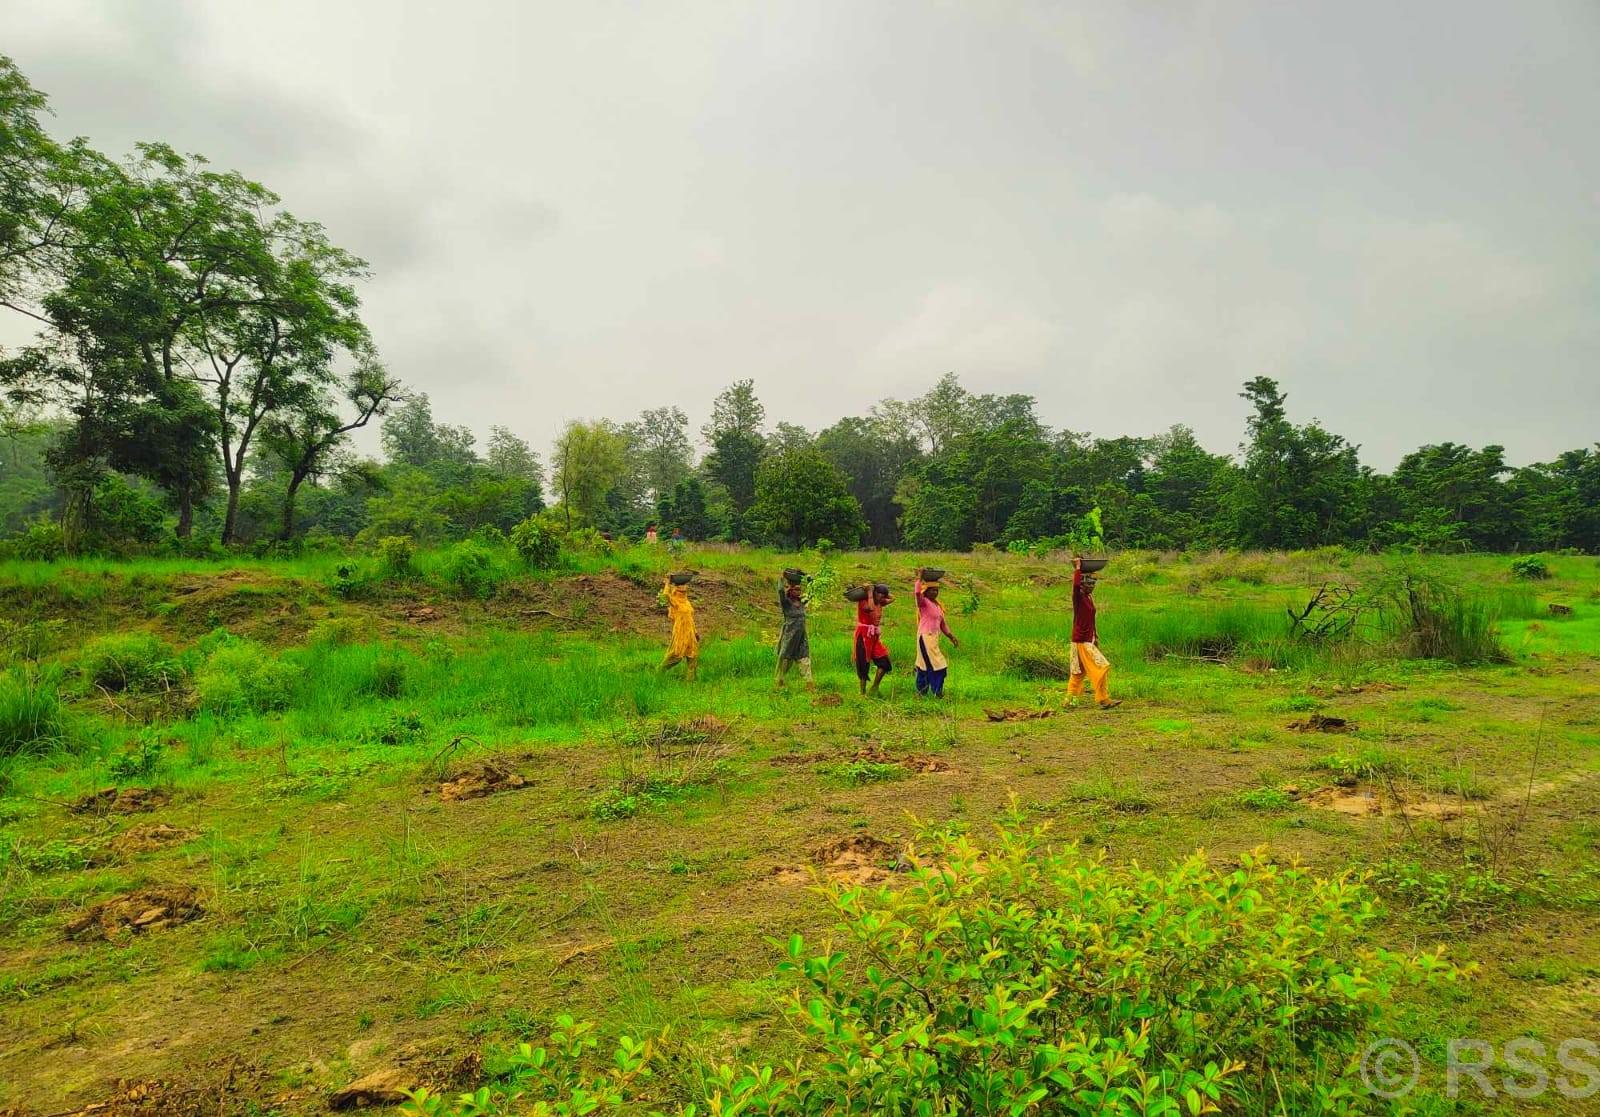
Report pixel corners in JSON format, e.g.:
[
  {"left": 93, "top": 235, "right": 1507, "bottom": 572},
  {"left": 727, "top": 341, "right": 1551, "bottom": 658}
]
[{"left": 0, "top": 547, "right": 1600, "bottom": 1114}]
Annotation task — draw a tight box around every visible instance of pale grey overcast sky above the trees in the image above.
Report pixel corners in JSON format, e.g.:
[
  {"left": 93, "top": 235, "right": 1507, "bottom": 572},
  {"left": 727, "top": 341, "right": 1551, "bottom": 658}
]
[{"left": 0, "top": 0, "right": 1600, "bottom": 467}]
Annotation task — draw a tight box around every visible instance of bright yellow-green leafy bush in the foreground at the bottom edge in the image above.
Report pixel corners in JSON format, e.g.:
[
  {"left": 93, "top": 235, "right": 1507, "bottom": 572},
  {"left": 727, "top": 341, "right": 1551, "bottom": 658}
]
[{"left": 402, "top": 823, "right": 1458, "bottom": 1117}]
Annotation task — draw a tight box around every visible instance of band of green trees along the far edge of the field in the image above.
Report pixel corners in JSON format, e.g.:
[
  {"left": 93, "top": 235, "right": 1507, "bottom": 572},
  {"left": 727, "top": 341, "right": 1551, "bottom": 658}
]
[{"left": 0, "top": 56, "right": 1600, "bottom": 555}]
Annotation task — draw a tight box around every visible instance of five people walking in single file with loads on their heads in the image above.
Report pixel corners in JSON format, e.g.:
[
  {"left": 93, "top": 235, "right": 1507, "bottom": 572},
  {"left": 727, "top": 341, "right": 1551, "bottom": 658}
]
[{"left": 661, "top": 559, "right": 1120, "bottom": 709}]
